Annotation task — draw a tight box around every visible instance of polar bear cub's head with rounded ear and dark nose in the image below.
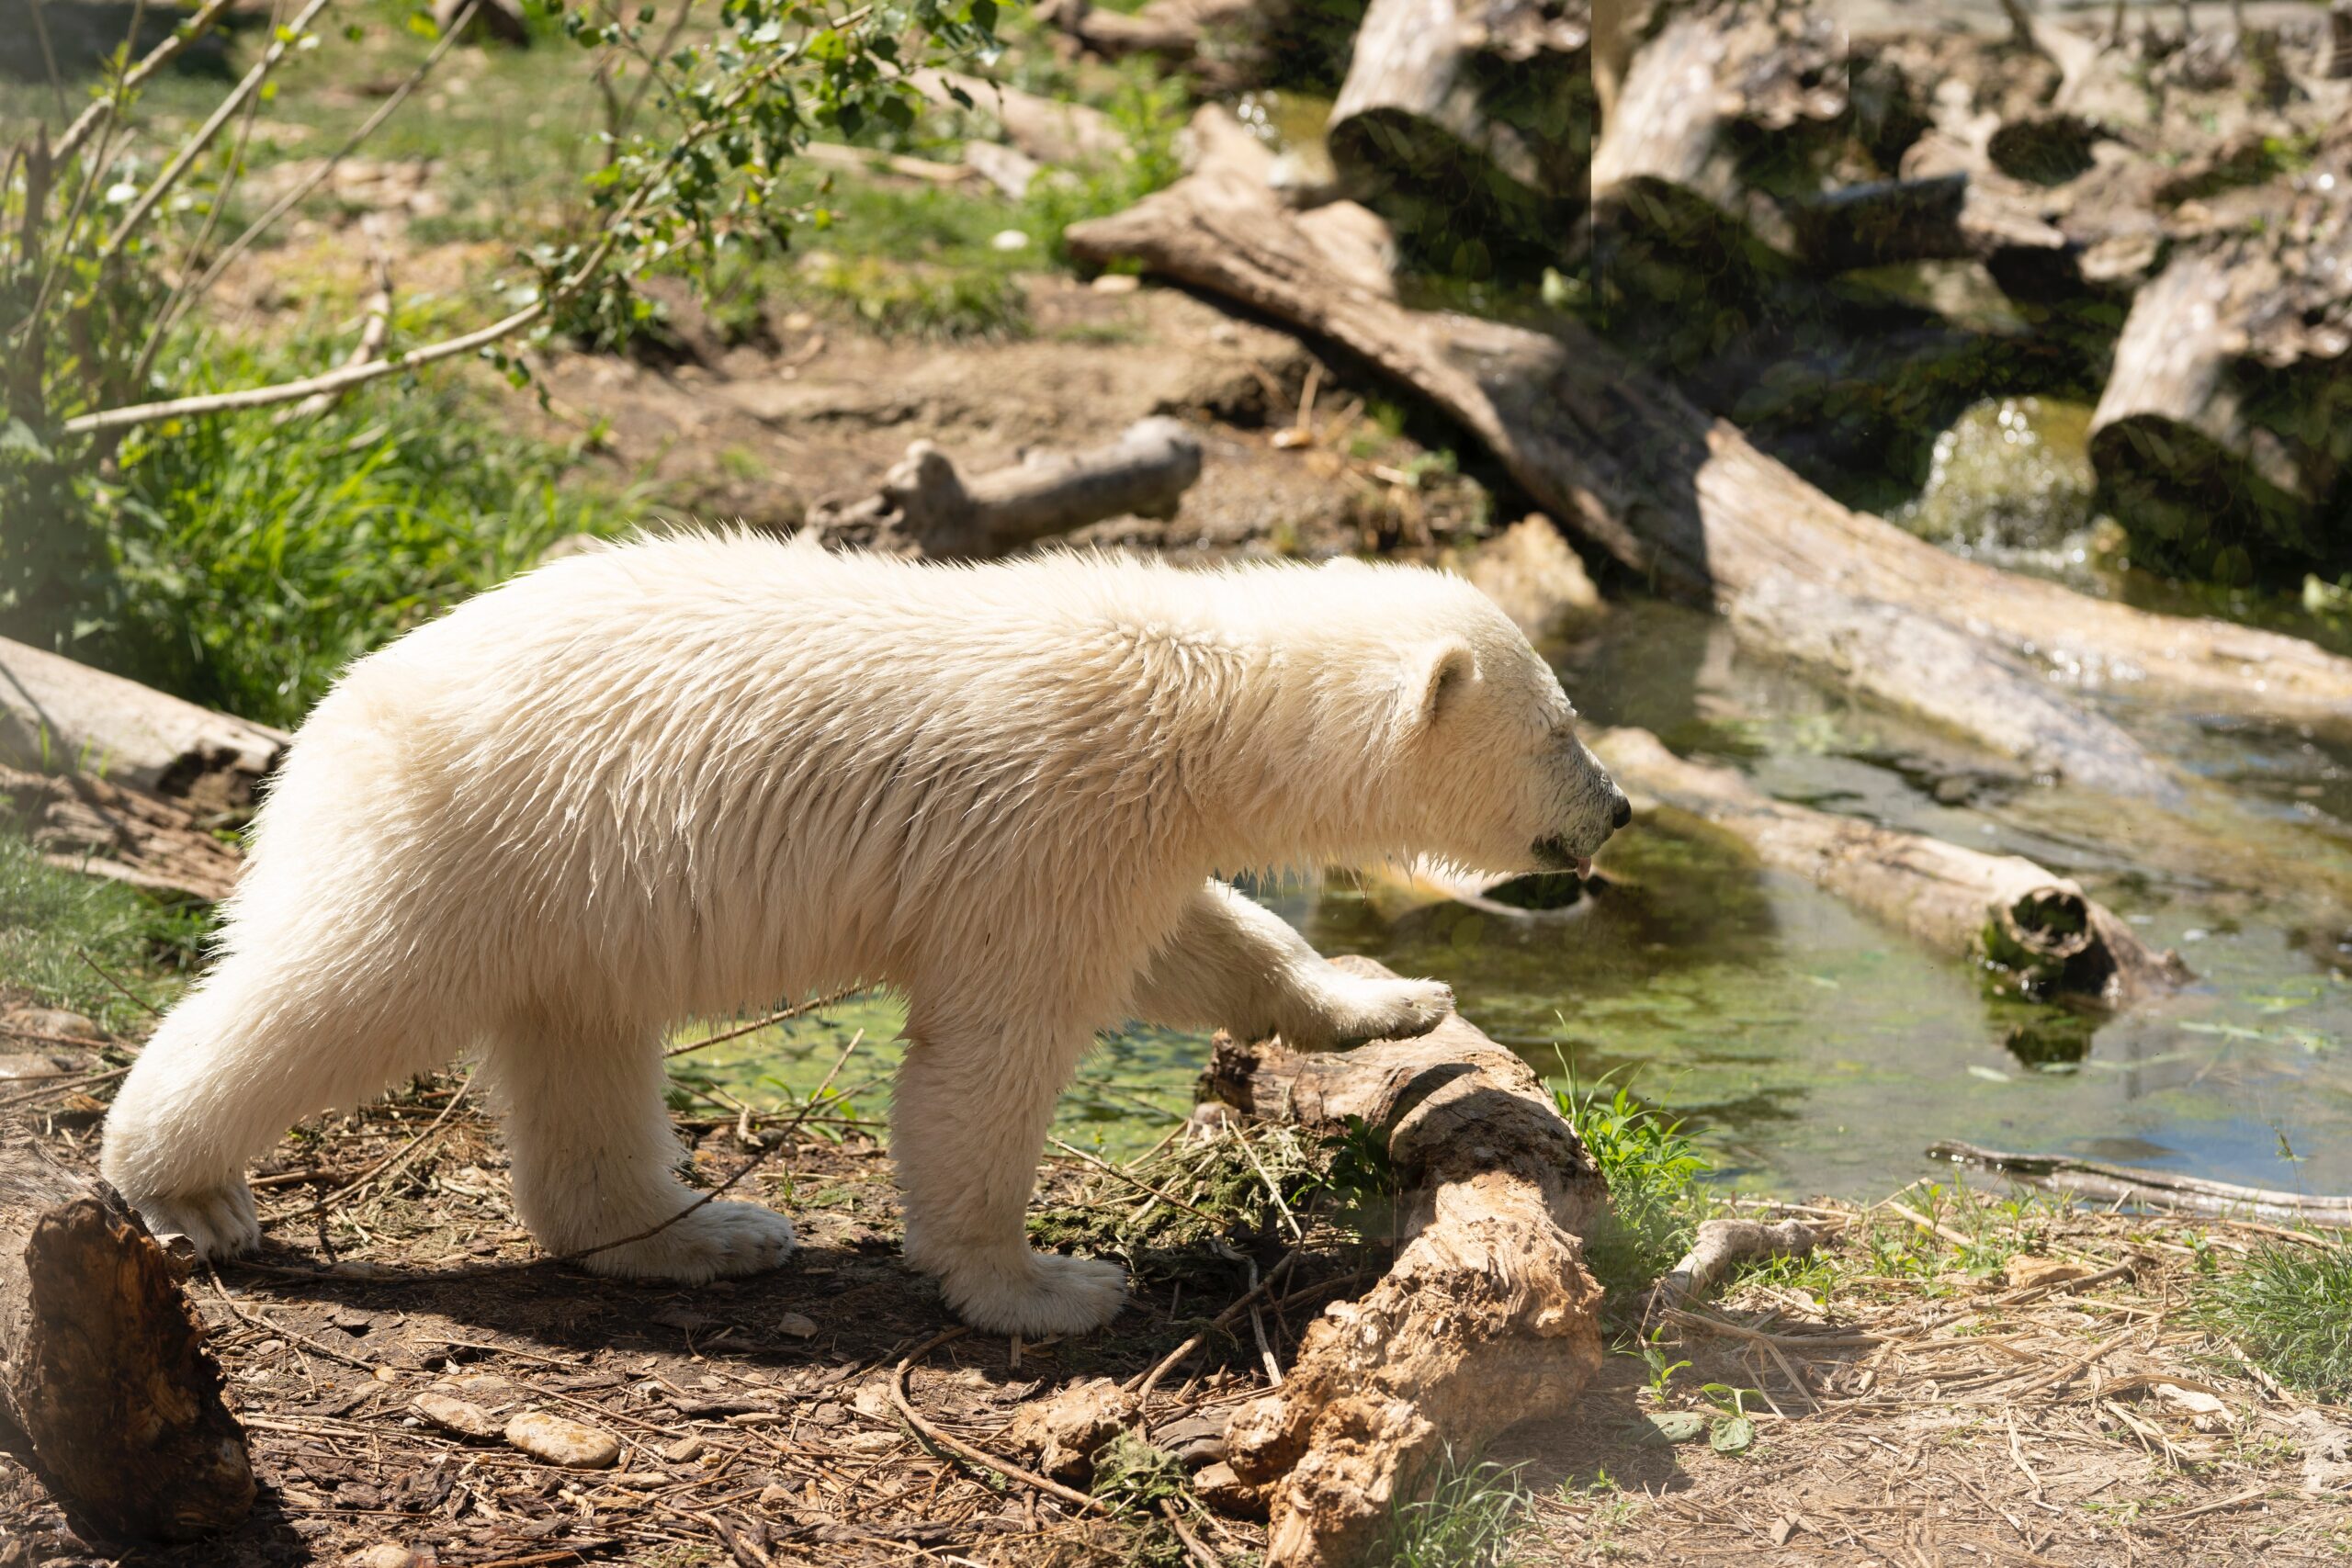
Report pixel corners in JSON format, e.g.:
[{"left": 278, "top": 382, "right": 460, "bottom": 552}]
[{"left": 1383, "top": 573, "right": 1633, "bottom": 874}]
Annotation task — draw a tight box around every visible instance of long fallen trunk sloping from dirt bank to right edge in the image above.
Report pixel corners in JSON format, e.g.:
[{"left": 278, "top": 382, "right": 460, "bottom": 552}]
[{"left": 1066, "top": 116, "right": 2352, "bottom": 728}]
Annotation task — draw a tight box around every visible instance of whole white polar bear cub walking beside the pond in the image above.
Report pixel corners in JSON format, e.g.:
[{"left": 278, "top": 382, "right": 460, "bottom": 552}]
[{"left": 106, "top": 534, "right": 1628, "bottom": 1336}]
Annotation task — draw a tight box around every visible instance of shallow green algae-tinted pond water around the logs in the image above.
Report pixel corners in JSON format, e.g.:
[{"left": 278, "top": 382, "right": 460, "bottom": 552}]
[{"left": 677, "top": 400, "right": 2352, "bottom": 1197}]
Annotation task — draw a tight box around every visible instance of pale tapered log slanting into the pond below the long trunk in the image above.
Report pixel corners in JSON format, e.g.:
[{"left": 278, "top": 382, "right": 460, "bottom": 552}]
[{"left": 1731, "top": 571, "right": 2180, "bottom": 804}]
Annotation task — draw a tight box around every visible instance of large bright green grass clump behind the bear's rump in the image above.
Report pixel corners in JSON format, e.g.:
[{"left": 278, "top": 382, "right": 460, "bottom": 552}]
[{"left": 68, "top": 348, "right": 628, "bottom": 724}]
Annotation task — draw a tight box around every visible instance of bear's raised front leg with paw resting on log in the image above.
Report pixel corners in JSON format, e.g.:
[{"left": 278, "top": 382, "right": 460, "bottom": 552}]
[{"left": 1131, "top": 882, "right": 1453, "bottom": 1051}]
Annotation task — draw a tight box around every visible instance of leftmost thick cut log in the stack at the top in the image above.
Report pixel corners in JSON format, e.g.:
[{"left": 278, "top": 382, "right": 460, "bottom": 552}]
[{"left": 1327, "top": 0, "right": 1592, "bottom": 253}]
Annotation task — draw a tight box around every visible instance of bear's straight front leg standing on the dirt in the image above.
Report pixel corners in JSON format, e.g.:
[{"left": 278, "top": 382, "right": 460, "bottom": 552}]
[{"left": 891, "top": 1009, "right": 1126, "bottom": 1336}]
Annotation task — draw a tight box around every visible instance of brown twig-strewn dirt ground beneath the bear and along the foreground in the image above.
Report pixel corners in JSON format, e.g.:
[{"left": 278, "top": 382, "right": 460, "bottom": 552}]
[{"left": 0, "top": 1001, "right": 2352, "bottom": 1568}]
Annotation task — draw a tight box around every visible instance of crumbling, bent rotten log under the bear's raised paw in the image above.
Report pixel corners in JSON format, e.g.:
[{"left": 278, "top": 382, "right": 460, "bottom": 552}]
[{"left": 1202, "top": 959, "right": 1606, "bottom": 1568}]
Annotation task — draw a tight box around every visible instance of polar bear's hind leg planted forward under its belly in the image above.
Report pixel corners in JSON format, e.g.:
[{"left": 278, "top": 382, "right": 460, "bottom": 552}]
[{"left": 484, "top": 1021, "right": 793, "bottom": 1286}]
